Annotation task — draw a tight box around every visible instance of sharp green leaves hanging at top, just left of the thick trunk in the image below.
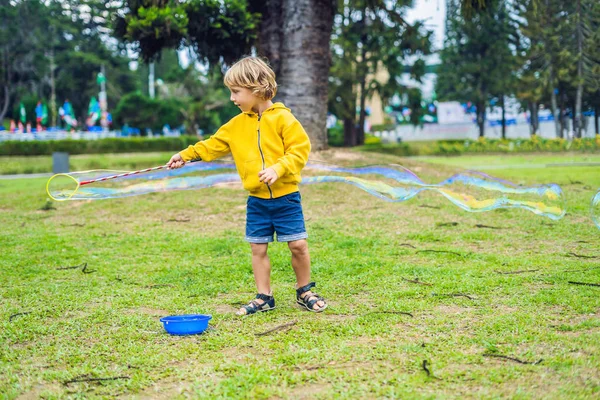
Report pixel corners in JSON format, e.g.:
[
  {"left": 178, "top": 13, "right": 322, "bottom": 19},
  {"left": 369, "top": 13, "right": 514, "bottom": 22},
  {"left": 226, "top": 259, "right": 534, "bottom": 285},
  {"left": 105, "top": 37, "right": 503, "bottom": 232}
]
[{"left": 115, "top": 0, "right": 260, "bottom": 65}]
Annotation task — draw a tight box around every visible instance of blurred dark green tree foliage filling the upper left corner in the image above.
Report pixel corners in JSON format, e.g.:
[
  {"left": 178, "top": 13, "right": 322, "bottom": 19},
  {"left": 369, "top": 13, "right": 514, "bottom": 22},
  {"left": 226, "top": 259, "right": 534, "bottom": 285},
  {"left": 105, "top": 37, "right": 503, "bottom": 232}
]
[{"left": 0, "top": 0, "right": 137, "bottom": 123}]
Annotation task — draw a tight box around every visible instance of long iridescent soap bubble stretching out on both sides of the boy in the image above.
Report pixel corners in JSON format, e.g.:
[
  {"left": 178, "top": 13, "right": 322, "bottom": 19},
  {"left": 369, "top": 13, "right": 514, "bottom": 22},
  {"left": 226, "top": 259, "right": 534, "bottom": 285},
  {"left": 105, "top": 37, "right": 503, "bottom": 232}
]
[{"left": 47, "top": 162, "right": 568, "bottom": 220}]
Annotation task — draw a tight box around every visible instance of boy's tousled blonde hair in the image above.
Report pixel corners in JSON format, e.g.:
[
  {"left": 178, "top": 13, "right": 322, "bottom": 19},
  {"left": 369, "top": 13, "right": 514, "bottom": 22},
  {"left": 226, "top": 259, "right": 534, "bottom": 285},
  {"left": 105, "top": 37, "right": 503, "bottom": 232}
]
[{"left": 223, "top": 57, "right": 277, "bottom": 100}]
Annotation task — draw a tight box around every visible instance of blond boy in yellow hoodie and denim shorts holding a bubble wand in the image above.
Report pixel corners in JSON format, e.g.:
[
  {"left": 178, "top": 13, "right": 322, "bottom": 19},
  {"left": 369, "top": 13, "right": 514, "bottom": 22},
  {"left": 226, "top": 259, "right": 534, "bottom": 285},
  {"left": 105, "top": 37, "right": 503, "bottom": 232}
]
[{"left": 167, "top": 57, "right": 327, "bottom": 315}]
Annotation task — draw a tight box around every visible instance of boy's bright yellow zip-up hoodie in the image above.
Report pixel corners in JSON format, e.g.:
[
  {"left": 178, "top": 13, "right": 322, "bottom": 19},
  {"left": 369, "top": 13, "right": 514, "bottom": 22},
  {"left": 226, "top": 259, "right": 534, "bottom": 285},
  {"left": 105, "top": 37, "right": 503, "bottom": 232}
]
[{"left": 179, "top": 103, "right": 310, "bottom": 199}]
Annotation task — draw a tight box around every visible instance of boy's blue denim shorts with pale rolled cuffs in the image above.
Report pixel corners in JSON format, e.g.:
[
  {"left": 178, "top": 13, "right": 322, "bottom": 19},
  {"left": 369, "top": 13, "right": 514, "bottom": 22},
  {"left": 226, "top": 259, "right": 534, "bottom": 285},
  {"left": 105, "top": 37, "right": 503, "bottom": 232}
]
[{"left": 246, "top": 192, "right": 308, "bottom": 243}]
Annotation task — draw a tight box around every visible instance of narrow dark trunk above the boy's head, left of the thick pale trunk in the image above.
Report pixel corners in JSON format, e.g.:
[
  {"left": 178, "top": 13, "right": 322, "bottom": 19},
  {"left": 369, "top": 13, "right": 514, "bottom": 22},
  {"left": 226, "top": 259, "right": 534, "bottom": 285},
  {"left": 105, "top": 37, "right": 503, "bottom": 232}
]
[{"left": 258, "top": 0, "right": 283, "bottom": 76}]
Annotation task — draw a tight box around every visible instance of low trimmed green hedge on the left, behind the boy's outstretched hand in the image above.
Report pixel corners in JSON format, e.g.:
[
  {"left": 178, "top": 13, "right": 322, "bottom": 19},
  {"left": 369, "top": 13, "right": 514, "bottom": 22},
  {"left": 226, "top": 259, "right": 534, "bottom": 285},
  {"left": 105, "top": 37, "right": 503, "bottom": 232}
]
[{"left": 0, "top": 136, "right": 198, "bottom": 156}]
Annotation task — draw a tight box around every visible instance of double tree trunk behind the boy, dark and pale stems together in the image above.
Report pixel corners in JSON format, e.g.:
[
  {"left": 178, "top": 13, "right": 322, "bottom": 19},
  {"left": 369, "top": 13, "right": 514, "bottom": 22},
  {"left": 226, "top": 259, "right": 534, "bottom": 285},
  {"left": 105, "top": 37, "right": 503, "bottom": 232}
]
[{"left": 250, "top": 0, "right": 336, "bottom": 150}]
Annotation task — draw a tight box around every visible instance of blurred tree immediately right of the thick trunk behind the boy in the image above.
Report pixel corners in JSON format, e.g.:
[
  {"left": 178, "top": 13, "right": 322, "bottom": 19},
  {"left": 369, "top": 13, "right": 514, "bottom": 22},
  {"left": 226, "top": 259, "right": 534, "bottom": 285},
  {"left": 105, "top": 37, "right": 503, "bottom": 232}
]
[{"left": 329, "top": 0, "right": 431, "bottom": 146}]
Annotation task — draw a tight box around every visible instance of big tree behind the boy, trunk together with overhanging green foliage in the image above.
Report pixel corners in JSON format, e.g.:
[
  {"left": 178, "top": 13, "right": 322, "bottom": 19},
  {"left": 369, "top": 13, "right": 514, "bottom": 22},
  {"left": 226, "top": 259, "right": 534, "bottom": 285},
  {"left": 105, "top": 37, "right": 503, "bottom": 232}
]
[{"left": 115, "top": 0, "right": 334, "bottom": 149}]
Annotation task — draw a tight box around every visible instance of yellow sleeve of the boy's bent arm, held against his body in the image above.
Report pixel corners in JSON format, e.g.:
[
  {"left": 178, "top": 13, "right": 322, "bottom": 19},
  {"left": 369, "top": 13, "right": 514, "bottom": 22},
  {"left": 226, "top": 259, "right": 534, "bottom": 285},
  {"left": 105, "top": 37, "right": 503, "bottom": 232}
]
[{"left": 272, "top": 117, "right": 310, "bottom": 178}]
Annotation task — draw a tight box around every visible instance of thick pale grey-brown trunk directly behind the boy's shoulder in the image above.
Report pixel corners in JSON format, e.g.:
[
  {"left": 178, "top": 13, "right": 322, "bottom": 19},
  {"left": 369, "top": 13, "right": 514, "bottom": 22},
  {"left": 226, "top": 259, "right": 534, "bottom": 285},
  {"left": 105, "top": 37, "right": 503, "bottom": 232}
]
[{"left": 277, "top": 0, "right": 335, "bottom": 150}]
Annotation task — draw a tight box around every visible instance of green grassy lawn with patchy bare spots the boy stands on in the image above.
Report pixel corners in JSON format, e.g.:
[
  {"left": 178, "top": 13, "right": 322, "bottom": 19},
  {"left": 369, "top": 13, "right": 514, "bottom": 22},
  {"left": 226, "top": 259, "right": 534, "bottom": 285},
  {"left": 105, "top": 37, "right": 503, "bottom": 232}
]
[{"left": 0, "top": 151, "right": 600, "bottom": 399}]
